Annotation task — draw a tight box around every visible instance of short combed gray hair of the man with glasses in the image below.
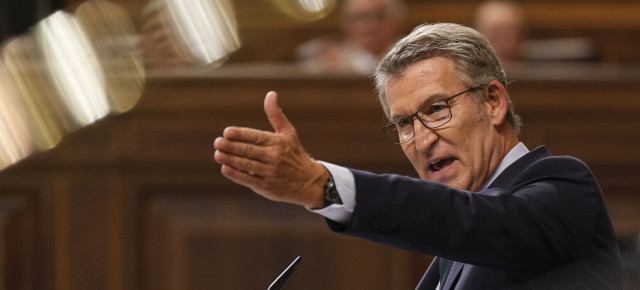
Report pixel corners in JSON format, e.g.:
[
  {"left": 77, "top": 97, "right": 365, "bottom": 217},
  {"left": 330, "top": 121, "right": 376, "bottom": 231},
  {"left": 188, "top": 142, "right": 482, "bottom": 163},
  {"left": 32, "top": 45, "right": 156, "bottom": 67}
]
[{"left": 374, "top": 23, "right": 522, "bottom": 134}]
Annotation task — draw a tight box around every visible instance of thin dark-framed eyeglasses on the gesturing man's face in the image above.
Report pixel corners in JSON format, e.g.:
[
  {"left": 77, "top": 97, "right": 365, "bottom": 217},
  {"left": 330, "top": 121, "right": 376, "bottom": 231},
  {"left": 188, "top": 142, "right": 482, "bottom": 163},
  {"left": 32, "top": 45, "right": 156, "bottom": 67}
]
[{"left": 382, "top": 87, "right": 480, "bottom": 144}]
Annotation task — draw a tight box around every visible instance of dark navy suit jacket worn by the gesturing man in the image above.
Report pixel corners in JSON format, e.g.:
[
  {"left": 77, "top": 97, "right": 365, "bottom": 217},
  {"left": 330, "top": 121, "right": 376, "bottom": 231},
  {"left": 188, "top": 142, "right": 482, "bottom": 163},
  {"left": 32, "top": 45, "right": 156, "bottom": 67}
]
[{"left": 328, "top": 147, "right": 622, "bottom": 289}]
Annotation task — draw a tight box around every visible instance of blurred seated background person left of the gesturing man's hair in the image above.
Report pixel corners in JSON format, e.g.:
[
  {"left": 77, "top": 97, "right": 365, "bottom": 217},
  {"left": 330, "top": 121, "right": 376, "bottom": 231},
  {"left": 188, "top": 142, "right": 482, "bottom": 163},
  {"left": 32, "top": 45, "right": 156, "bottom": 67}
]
[{"left": 296, "top": 0, "right": 406, "bottom": 75}]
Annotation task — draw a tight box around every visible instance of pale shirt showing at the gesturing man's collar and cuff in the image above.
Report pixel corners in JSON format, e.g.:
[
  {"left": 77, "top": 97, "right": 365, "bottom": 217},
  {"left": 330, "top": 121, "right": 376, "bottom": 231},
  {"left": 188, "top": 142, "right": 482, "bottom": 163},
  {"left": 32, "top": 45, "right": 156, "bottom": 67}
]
[{"left": 309, "top": 142, "right": 529, "bottom": 225}]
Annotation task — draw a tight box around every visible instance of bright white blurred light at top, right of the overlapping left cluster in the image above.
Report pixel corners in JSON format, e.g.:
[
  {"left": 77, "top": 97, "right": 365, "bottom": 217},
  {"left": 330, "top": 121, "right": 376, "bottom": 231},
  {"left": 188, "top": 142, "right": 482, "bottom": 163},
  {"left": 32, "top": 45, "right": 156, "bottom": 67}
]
[{"left": 165, "top": 0, "right": 240, "bottom": 64}]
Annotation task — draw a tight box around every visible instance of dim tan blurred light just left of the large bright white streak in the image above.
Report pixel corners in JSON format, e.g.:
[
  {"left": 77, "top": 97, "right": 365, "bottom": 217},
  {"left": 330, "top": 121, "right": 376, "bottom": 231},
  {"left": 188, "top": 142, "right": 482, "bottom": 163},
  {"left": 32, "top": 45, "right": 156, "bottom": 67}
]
[{"left": 2, "top": 35, "right": 67, "bottom": 149}]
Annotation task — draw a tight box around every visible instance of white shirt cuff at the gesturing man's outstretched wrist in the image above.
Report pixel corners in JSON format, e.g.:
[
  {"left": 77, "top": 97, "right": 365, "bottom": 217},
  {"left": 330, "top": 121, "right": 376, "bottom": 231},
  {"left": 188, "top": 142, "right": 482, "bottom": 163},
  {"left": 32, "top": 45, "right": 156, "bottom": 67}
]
[{"left": 307, "top": 161, "right": 356, "bottom": 225}]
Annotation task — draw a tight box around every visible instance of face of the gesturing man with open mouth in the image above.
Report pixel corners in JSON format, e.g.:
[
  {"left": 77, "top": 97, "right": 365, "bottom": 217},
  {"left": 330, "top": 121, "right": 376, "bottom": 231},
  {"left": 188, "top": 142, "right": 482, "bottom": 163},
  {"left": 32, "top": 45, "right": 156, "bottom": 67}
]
[{"left": 386, "top": 57, "right": 503, "bottom": 191}]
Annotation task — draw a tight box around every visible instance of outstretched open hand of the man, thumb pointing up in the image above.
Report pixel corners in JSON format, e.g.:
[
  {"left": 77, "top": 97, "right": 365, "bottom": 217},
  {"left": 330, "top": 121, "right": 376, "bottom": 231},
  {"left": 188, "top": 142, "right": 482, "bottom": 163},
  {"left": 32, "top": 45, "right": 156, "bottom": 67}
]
[{"left": 213, "top": 92, "right": 330, "bottom": 208}]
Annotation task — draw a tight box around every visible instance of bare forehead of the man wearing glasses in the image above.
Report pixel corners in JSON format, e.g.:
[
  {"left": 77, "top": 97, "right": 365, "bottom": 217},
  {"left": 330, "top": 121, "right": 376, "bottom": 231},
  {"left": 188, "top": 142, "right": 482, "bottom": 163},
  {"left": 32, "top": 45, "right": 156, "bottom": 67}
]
[{"left": 385, "top": 57, "right": 464, "bottom": 116}]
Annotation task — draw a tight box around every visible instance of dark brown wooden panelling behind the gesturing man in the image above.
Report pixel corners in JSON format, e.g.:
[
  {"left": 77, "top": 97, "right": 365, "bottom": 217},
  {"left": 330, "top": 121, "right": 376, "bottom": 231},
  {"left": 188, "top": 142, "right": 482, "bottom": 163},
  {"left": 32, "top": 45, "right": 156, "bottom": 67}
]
[{"left": 0, "top": 62, "right": 640, "bottom": 290}]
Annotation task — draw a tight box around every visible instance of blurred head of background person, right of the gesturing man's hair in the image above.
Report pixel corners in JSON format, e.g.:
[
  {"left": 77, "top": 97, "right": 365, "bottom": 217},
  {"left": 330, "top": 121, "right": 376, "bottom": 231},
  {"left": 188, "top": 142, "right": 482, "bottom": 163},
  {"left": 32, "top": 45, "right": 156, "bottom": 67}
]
[{"left": 473, "top": 0, "right": 526, "bottom": 69}]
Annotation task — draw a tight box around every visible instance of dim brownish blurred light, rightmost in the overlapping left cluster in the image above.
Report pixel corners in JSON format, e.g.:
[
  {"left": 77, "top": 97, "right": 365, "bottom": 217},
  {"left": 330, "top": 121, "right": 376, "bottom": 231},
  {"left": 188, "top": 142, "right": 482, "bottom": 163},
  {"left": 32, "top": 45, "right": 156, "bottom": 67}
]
[{"left": 75, "top": 0, "right": 145, "bottom": 113}]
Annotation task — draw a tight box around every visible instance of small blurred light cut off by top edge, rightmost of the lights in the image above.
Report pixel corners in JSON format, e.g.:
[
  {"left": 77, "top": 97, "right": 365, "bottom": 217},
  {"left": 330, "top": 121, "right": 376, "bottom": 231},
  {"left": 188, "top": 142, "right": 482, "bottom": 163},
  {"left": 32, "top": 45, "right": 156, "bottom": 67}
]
[{"left": 271, "top": 0, "right": 336, "bottom": 21}]
